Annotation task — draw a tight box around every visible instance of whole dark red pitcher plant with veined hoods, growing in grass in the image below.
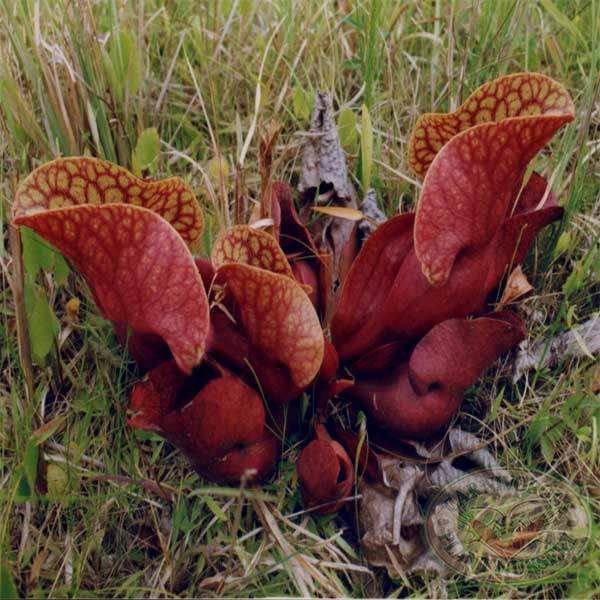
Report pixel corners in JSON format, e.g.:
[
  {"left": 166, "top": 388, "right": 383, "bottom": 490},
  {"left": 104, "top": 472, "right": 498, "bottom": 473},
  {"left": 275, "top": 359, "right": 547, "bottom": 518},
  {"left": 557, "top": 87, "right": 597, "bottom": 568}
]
[{"left": 13, "top": 73, "right": 575, "bottom": 514}]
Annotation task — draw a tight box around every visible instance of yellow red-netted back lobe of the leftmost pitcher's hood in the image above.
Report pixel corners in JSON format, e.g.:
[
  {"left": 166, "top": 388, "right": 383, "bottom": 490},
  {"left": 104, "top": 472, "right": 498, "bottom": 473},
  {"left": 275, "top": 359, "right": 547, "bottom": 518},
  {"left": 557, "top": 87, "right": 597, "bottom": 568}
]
[{"left": 13, "top": 157, "right": 204, "bottom": 247}]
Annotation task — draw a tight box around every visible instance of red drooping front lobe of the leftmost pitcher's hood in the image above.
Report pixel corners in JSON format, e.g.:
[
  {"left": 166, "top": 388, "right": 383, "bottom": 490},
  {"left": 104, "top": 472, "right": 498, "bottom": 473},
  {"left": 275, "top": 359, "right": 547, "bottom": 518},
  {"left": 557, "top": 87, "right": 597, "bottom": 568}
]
[{"left": 15, "top": 204, "right": 209, "bottom": 373}]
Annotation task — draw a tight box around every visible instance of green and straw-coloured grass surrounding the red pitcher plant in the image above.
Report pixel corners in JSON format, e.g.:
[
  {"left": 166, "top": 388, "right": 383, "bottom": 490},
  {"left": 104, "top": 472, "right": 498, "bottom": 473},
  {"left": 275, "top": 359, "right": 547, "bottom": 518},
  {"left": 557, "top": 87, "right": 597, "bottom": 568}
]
[{"left": 0, "top": 0, "right": 600, "bottom": 598}]
